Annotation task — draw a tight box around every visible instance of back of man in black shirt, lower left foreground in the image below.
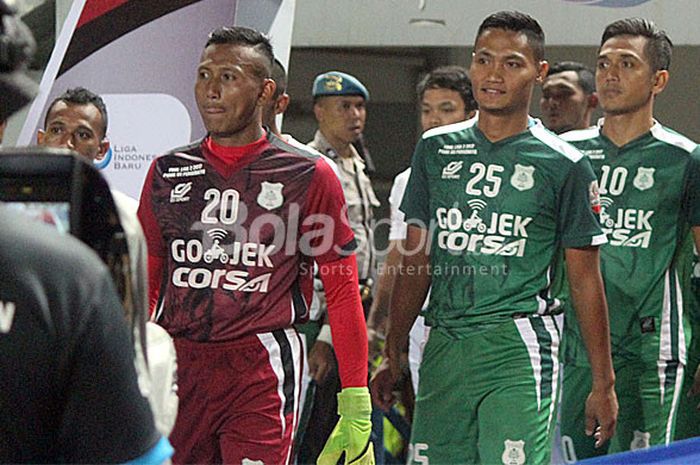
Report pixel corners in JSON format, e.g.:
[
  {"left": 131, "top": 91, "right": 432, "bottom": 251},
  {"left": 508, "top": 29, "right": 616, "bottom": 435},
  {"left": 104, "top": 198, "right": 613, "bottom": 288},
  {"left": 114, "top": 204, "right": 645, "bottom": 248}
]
[{"left": 0, "top": 207, "right": 172, "bottom": 464}]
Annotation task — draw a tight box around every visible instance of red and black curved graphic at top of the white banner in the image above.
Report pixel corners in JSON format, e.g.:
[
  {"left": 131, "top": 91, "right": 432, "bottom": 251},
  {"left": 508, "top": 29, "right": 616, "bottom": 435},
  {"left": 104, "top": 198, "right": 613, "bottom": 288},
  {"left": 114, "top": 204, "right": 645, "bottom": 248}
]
[{"left": 58, "top": 0, "right": 201, "bottom": 76}]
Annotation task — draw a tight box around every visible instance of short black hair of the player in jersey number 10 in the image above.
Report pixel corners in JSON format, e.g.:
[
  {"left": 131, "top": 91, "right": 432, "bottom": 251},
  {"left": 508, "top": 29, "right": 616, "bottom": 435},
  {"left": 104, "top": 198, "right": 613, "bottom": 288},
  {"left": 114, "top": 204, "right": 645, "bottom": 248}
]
[{"left": 600, "top": 18, "right": 673, "bottom": 72}]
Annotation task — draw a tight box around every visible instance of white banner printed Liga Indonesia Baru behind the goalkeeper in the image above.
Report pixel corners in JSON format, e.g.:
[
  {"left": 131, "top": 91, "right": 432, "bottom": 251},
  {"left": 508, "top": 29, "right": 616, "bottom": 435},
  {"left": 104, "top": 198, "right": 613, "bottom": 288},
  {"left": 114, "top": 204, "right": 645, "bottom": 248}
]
[{"left": 17, "top": 0, "right": 295, "bottom": 198}]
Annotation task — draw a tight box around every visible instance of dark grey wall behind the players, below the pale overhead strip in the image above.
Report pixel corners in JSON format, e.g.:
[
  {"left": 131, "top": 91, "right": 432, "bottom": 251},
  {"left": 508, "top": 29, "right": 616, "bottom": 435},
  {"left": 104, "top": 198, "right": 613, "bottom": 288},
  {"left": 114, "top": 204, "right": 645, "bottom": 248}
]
[{"left": 283, "top": 46, "right": 700, "bottom": 180}]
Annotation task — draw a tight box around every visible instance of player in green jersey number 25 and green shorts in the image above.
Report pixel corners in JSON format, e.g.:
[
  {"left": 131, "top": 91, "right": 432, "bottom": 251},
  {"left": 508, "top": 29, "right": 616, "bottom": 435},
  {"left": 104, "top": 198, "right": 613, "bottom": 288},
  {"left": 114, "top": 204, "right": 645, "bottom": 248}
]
[{"left": 373, "top": 12, "right": 617, "bottom": 464}]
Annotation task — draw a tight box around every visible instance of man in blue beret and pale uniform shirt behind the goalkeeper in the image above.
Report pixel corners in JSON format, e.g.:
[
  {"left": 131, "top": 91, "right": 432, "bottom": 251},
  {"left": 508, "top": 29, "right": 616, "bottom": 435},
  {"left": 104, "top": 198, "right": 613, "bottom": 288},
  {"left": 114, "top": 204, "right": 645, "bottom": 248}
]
[{"left": 299, "top": 71, "right": 379, "bottom": 463}]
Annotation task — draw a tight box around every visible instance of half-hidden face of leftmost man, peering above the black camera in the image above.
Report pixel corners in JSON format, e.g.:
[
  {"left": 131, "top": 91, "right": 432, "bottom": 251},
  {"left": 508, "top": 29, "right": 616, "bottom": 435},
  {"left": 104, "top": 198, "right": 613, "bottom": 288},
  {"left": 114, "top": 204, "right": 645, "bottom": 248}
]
[{"left": 37, "top": 100, "right": 109, "bottom": 160}]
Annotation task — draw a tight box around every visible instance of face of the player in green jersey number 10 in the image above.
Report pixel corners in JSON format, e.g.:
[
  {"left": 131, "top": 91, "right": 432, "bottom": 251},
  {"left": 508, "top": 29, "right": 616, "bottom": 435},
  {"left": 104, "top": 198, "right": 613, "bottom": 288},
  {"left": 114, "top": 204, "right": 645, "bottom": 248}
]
[{"left": 595, "top": 35, "right": 660, "bottom": 115}]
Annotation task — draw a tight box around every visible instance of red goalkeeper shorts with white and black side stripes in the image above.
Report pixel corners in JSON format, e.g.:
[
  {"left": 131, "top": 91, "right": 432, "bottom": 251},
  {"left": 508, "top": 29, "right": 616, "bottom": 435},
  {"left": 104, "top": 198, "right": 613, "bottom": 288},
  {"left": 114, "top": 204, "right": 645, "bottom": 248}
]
[{"left": 170, "top": 329, "right": 302, "bottom": 464}]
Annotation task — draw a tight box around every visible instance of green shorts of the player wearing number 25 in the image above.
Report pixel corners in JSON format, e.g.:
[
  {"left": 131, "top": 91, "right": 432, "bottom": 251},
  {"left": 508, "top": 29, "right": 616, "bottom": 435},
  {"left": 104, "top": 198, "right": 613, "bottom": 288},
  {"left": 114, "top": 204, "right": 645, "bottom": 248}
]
[{"left": 408, "top": 316, "right": 561, "bottom": 465}]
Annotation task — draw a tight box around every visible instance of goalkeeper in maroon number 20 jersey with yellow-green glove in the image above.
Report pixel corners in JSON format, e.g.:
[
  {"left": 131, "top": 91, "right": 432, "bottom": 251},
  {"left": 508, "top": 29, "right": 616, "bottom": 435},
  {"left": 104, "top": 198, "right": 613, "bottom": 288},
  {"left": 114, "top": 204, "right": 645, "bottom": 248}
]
[{"left": 139, "top": 27, "right": 373, "bottom": 464}]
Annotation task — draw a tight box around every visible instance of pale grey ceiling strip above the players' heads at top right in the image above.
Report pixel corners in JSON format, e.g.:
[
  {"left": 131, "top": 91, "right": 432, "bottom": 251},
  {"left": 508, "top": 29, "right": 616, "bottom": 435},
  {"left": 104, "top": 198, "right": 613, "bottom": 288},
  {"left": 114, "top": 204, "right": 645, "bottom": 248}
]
[{"left": 292, "top": 0, "right": 700, "bottom": 47}]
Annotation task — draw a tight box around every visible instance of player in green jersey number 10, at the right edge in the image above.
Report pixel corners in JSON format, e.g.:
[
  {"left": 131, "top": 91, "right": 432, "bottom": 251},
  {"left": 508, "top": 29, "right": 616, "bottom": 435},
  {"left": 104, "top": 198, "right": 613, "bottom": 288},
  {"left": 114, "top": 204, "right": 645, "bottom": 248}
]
[{"left": 561, "top": 18, "right": 700, "bottom": 462}]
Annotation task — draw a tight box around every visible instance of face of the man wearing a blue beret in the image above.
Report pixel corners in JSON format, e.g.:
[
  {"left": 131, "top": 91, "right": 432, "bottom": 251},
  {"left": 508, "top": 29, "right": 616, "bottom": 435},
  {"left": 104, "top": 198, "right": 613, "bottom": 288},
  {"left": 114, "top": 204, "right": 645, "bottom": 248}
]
[{"left": 315, "top": 95, "right": 367, "bottom": 144}]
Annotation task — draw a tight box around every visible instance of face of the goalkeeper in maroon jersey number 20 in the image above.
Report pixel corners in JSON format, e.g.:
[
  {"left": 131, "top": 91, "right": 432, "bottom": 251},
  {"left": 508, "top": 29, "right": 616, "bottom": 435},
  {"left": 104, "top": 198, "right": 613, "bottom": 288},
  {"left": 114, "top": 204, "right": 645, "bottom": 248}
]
[{"left": 194, "top": 44, "right": 274, "bottom": 145}]
